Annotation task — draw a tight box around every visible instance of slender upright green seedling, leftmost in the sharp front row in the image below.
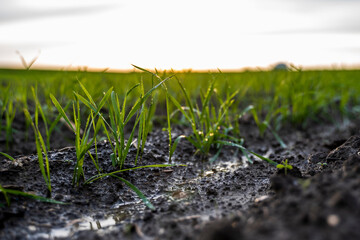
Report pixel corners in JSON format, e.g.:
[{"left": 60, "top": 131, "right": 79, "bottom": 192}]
[{"left": 24, "top": 106, "right": 51, "bottom": 196}]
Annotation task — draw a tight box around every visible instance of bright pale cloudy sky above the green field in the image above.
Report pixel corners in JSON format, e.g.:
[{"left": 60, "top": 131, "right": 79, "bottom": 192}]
[{"left": 0, "top": 0, "right": 360, "bottom": 70}]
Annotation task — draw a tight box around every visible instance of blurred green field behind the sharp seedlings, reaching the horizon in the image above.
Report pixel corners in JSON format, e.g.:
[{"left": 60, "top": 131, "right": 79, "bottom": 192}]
[{"left": 0, "top": 69, "right": 360, "bottom": 126}]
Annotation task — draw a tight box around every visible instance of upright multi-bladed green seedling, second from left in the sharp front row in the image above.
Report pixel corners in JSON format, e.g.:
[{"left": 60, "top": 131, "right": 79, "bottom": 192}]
[{"left": 50, "top": 85, "right": 112, "bottom": 185}]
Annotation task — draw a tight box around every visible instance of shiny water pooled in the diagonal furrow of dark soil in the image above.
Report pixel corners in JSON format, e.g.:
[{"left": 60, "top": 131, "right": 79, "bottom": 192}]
[{"left": 28, "top": 150, "right": 272, "bottom": 239}]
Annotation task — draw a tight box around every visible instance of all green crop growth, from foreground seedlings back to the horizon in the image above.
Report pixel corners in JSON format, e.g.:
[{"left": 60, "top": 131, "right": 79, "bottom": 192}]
[{"left": 0, "top": 66, "right": 360, "bottom": 239}]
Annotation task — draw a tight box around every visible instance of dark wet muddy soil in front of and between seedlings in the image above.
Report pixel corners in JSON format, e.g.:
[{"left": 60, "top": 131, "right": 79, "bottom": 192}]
[{"left": 0, "top": 117, "right": 360, "bottom": 239}]
